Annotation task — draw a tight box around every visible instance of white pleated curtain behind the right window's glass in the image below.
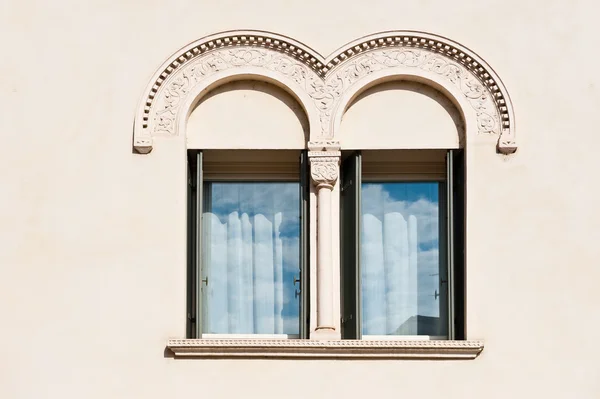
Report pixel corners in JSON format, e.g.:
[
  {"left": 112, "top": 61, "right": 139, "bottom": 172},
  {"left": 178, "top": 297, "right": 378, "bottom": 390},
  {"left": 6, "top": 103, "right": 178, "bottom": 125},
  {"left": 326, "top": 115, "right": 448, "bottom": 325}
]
[{"left": 361, "top": 212, "right": 418, "bottom": 335}]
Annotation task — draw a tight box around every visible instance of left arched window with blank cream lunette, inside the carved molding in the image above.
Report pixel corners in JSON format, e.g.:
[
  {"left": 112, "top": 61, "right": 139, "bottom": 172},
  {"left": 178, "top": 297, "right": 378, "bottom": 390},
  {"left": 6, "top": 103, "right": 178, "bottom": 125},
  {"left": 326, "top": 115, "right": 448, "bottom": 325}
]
[{"left": 186, "top": 80, "right": 308, "bottom": 338}]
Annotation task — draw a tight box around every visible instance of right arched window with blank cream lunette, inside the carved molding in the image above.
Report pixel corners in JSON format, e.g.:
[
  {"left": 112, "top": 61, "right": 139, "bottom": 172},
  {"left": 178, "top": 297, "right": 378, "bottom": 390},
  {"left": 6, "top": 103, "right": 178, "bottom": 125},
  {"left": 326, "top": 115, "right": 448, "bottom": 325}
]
[{"left": 338, "top": 80, "right": 465, "bottom": 339}]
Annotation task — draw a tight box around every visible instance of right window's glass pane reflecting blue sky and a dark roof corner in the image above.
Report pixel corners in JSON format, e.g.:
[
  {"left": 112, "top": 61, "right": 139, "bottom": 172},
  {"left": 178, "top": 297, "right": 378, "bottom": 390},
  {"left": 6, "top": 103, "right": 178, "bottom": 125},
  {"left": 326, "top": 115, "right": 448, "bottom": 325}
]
[{"left": 360, "top": 182, "right": 447, "bottom": 336}]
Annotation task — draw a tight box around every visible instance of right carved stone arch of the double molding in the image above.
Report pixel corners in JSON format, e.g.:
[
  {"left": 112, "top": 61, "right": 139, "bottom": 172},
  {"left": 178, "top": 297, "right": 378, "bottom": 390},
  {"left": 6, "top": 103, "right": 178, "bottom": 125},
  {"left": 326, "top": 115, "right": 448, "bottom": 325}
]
[{"left": 326, "top": 31, "right": 517, "bottom": 154}]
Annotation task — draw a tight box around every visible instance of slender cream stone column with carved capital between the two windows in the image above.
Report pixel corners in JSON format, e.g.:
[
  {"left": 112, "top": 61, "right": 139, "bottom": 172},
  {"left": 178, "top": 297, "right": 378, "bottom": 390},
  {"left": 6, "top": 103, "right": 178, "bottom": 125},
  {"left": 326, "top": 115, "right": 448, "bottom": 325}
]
[{"left": 308, "top": 142, "right": 341, "bottom": 340}]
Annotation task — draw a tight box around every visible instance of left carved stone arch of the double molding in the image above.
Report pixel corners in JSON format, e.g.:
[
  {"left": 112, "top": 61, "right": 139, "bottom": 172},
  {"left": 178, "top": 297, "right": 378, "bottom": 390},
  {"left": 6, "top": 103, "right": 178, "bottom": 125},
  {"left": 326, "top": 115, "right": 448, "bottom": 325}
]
[{"left": 133, "top": 31, "right": 323, "bottom": 154}]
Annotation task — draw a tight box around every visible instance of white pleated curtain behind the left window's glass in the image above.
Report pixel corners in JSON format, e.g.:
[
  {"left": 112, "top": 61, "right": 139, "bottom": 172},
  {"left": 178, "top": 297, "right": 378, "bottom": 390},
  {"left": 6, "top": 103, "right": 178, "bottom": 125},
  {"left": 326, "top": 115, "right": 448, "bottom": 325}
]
[{"left": 202, "top": 212, "right": 284, "bottom": 334}]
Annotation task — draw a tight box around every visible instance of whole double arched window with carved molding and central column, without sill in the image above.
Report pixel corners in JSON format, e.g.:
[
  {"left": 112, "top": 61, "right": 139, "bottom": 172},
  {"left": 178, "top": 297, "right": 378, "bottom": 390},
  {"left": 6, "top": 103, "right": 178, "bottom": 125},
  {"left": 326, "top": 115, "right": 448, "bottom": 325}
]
[{"left": 134, "top": 31, "right": 516, "bottom": 358}]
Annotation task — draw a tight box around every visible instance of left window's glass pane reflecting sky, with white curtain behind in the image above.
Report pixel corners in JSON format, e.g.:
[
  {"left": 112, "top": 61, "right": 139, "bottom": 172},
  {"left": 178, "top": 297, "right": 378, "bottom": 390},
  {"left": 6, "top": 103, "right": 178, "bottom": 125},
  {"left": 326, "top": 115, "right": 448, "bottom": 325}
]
[{"left": 202, "top": 182, "right": 300, "bottom": 334}]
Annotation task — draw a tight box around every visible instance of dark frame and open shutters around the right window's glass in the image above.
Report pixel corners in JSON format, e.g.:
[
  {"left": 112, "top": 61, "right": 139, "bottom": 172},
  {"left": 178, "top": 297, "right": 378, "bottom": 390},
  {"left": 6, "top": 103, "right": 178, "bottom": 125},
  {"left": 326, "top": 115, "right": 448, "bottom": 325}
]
[{"left": 340, "top": 149, "right": 466, "bottom": 341}]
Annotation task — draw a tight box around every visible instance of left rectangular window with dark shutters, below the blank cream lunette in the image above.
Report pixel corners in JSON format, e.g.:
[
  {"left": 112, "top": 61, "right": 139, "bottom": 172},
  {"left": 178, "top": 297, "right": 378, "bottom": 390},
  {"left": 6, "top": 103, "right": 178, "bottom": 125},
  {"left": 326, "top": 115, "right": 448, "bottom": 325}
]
[{"left": 188, "top": 150, "right": 308, "bottom": 338}]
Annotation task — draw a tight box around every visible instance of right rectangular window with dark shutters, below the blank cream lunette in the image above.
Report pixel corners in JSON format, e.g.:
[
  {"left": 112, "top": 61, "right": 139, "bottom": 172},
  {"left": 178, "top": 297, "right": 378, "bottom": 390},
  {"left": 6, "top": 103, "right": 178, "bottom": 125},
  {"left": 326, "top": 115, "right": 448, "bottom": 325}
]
[{"left": 341, "top": 150, "right": 464, "bottom": 339}]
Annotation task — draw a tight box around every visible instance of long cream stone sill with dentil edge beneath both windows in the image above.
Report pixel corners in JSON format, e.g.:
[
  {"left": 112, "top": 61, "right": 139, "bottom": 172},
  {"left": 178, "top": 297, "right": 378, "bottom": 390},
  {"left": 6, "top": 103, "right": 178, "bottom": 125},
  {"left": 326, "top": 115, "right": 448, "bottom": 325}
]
[{"left": 167, "top": 339, "right": 483, "bottom": 359}]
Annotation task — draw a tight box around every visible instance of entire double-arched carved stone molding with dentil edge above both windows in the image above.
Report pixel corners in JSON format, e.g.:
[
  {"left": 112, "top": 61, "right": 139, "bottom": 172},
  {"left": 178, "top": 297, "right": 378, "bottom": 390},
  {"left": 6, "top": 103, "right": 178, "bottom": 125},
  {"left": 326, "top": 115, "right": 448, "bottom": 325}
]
[{"left": 134, "top": 31, "right": 517, "bottom": 154}]
